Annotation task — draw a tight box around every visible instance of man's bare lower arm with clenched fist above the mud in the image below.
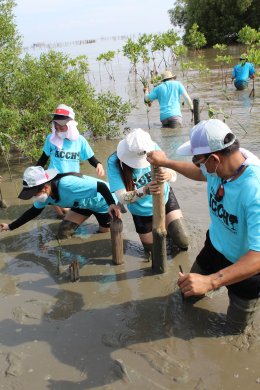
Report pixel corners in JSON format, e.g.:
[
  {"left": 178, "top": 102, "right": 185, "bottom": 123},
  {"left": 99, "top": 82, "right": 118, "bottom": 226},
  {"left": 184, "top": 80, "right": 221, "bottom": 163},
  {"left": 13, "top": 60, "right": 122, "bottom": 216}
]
[{"left": 178, "top": 250, "right": 260, "bottom": 297}]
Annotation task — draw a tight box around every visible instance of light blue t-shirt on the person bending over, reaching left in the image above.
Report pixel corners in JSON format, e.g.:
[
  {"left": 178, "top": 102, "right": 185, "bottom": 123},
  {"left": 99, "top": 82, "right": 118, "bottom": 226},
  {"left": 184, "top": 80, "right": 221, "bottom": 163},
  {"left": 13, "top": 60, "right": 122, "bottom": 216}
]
[{"left": 34, "top": 175, "right": 117, "bottom": 213}]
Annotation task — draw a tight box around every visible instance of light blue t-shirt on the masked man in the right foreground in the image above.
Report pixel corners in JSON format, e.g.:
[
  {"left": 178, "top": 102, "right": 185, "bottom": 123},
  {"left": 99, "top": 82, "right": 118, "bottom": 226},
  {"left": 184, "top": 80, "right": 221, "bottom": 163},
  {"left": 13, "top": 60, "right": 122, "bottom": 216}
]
[{"left": 206, "top": 165, "right": 260, "bottom": 263}]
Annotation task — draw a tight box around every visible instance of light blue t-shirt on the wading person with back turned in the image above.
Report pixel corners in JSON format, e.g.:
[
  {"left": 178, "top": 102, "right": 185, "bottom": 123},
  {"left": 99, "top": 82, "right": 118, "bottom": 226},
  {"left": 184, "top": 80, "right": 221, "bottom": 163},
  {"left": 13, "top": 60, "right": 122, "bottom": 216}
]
[{"left": 146, "top": 80, "right": 186, "bottom": 121}]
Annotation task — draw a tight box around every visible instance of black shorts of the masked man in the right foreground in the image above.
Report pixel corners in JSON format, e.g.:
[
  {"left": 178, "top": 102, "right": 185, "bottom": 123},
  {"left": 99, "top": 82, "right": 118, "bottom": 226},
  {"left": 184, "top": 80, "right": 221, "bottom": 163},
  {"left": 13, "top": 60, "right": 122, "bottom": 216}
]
[{"left": 196, "top": 232, "right": 260, "bottom": 299}]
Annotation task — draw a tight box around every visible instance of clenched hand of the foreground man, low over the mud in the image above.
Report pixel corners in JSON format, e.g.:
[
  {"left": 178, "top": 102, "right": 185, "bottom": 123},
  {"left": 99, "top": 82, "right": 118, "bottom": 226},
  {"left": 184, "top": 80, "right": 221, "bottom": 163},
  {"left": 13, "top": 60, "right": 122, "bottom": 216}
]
[{"left": 178, "top": 272, "right": 213, "bottom": 297}]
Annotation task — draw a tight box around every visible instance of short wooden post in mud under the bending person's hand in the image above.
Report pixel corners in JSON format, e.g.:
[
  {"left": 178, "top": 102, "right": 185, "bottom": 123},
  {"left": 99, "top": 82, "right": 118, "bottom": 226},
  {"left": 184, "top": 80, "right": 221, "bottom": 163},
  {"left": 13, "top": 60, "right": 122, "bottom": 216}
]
[{"left": 110, "top": 215, "right": 124, "bottom": 265}]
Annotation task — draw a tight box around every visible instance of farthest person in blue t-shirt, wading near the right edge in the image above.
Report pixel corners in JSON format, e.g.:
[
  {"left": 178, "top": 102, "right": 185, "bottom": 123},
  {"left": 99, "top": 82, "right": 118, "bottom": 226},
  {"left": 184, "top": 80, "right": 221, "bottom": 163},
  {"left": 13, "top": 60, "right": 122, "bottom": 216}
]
[{"left": 232, "top": 54, "right": 255, "bottom": 90}]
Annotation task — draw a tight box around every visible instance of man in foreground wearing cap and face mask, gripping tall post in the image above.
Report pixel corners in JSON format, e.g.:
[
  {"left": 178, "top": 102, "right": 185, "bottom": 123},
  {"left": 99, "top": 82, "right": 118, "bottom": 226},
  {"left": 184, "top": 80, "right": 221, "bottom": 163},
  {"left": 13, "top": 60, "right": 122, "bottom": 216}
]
[{"left": 148, "top": 119, "right": 260, "bottom": 333}]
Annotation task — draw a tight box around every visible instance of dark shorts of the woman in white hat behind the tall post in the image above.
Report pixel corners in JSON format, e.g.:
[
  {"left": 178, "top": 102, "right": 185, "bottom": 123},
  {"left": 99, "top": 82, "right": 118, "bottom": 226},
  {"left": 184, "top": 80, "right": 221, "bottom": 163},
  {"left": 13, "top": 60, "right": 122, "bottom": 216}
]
[{"left": 133, "top": 188, "right": 180, "bottom": 234}]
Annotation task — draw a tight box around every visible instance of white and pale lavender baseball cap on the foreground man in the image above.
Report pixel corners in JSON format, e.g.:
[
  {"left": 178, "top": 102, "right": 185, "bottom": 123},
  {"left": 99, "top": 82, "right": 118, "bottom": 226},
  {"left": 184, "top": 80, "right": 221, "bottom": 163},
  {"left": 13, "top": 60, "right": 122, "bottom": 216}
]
[{"left": 176, "top": 119, "right": 236, "bottom": 156}]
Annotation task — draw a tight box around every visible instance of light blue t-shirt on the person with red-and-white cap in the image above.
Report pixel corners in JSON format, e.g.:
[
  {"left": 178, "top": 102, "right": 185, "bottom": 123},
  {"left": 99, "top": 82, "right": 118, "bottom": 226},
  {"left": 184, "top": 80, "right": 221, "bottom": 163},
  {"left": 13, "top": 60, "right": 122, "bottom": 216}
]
[{"left": 43, "top": 134, "right": 94, "bottom": 173}]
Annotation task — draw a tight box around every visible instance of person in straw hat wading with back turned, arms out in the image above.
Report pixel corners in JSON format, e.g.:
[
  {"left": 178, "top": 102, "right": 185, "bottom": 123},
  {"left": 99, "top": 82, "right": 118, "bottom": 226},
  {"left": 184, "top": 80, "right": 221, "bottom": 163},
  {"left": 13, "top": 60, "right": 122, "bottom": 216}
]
[{"left": 144, "top": 70, "right": 193, "bottom": 129}]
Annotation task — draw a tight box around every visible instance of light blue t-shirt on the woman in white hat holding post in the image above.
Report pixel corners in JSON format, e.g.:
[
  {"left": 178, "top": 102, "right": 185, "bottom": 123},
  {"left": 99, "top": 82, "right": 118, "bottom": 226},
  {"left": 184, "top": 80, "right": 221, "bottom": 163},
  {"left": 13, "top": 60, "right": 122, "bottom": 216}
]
[{"left": 107, "top": 150, "right": 169, "bottom": 216}]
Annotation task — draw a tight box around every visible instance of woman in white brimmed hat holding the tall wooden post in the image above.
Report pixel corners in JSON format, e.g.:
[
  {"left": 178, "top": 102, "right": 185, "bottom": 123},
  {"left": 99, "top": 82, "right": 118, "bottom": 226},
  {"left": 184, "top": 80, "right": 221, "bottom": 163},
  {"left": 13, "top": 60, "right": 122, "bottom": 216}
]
[{"left": 107, "top": 129, "right": 188, "bottom": 257}]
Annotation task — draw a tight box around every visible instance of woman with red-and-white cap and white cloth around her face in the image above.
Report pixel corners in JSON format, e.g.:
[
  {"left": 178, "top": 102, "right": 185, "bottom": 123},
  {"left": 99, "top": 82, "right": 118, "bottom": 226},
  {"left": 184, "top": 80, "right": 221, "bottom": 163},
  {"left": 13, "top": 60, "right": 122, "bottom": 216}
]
[{"left": 36, "top": 104, "right": 105, "bottom": 218}]
